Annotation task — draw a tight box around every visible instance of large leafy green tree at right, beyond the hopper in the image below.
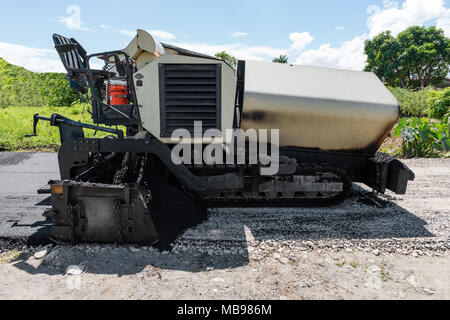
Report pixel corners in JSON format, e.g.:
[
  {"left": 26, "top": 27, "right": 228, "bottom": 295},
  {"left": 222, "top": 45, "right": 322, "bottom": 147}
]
[{"left": 364, "top": 26, "right": 450, "bottom": 88}]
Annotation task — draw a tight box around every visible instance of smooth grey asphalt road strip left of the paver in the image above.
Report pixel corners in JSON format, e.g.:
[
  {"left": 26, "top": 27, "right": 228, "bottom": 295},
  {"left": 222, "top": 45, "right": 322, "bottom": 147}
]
[{"left": 0, "top": 152, "right": 59, "bottom": 239}]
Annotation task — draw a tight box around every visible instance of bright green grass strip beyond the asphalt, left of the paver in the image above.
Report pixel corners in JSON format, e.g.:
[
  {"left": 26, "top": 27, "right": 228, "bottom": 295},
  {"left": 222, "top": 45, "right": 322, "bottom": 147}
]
[{"left": 0, "top": 104, "right": 116, "bottom": 151}]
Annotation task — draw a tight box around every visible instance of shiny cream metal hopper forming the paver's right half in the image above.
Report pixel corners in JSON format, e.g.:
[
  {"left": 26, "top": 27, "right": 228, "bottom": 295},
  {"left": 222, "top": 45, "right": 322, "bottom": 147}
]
[{"left": 241, "top": 61, "right": 399, "bottom": 152}]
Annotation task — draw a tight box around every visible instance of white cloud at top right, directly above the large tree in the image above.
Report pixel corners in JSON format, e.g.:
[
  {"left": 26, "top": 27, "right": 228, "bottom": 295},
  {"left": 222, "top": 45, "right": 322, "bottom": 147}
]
[{"left": 367, "top": 0, "right": 446, "bottom": 37}]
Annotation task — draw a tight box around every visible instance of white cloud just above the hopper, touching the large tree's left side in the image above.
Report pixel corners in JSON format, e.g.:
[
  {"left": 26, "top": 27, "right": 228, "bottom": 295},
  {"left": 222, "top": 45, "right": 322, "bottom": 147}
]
[{"left": 296, "top": 36, "right": 366, "bottom": 70}]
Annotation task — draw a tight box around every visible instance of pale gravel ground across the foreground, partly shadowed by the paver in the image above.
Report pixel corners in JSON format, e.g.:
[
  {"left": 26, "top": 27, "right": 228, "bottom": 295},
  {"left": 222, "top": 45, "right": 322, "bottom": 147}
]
[{"left": 0, "top": 159, "right": 450, "bottom": 299}]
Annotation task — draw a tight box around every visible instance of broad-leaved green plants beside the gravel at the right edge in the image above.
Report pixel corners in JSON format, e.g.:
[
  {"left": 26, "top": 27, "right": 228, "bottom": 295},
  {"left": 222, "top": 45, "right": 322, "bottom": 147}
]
[{"left": 394, "top": 118, "right": 450, "bottom": 158}]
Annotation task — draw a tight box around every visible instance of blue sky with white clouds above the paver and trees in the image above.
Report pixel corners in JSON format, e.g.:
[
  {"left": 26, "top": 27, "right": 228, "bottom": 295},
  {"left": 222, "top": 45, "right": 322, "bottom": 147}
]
[{"left": 0, "top": 0, "right": 450, "bottom": 71}]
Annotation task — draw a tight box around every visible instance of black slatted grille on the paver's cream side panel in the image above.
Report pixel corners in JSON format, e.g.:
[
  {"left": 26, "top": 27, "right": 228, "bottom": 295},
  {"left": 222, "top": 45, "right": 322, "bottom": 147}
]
[{"left": 159, "top": 63, "right": 222, "bottom": 137}]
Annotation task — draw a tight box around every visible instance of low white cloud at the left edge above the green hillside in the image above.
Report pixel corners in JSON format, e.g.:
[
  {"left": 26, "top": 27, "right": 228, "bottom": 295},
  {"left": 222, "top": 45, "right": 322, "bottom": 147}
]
[{"left": 0, "top": 42, "right": 65, "bottom": 72}]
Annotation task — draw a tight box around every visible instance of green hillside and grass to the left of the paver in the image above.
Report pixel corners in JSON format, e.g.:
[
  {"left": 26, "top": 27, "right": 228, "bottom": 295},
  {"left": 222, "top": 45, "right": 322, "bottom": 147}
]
[{"left": 0, "top": 58, "right": 112, "bottom": 151}]
